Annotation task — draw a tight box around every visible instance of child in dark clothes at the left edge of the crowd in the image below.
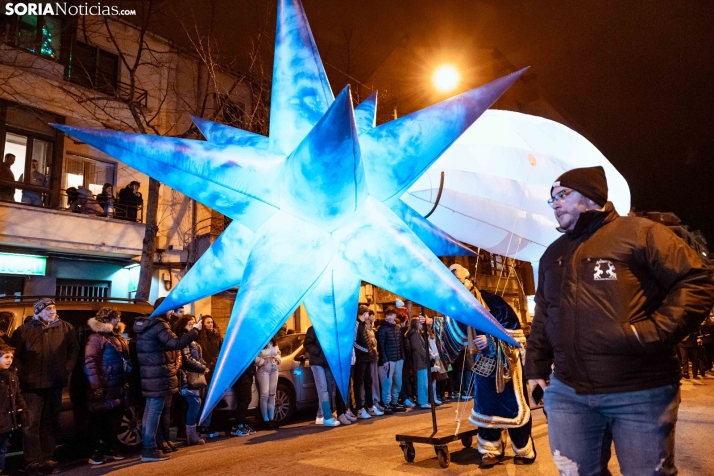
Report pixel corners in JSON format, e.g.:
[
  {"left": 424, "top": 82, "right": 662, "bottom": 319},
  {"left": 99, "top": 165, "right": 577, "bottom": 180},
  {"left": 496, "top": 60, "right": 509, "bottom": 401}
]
[{"left": 0, "top": 344, "right": 25, "bottom": 473}]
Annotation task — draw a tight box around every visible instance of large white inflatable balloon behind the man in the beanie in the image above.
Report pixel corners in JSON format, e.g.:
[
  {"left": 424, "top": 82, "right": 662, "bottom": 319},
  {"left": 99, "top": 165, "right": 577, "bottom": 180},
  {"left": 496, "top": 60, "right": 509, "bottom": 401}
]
[{"left": 402, "top": 110, "right": 630, "bottom": 263}]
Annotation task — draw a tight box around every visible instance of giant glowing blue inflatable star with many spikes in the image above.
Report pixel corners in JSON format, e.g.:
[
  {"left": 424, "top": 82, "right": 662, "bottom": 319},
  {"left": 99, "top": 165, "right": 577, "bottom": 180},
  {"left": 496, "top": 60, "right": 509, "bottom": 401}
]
[{"left": 55, "top": 0, "right": 522, "bottom": 418}]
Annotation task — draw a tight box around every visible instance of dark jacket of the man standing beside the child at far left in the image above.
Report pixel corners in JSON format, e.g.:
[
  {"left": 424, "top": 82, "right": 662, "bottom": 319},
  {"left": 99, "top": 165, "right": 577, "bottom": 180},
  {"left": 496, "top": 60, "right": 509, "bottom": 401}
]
[{"left": 12, "top": 318, "right": 79, "bottom": 392}]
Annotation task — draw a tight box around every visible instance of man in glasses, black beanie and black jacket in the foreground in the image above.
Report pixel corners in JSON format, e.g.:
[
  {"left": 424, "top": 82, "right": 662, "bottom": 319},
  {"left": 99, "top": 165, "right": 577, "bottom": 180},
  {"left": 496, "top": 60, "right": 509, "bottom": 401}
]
[{"left": 525, "top": 167, "right": 714, "bottom": 475}]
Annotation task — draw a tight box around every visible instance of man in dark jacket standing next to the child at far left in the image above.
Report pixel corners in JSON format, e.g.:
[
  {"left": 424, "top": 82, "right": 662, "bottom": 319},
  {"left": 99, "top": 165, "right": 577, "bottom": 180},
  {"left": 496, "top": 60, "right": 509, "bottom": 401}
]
[{"left": 12, "top": 298, "right": 79, "bottom": 474}]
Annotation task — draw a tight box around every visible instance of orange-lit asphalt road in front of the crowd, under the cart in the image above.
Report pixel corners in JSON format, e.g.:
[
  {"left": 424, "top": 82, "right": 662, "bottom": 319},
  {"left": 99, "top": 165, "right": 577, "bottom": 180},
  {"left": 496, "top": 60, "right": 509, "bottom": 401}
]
[{"left": 46, "top": 377, "right": 714, "bottom": 476}]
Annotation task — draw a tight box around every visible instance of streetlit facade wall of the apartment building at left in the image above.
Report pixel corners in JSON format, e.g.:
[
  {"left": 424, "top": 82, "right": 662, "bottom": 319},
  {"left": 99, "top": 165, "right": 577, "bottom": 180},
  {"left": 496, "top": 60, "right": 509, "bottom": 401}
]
[{"left": 0, "top": 13, "right": 251, "bottom": 312}]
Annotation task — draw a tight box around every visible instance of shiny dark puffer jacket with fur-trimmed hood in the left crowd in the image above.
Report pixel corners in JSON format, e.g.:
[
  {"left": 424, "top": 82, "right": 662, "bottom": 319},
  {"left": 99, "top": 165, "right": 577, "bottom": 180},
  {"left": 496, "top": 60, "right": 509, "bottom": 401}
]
[{"left": 84, "top": 318, "right": 129, "bottom": 411}]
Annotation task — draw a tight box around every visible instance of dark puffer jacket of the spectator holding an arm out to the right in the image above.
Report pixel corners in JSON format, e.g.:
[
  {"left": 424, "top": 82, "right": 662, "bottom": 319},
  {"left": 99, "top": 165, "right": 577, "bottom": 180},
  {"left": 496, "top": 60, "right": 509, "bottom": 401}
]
[{"left": 134, "top": 316, "right": 198, "bottom": 397}]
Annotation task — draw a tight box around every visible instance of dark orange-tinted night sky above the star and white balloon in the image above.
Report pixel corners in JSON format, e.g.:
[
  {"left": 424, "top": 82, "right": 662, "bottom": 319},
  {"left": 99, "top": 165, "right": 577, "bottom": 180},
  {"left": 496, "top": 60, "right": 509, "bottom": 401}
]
[{"left": 155, "top": 0, "right": 714, "bottom": 244}]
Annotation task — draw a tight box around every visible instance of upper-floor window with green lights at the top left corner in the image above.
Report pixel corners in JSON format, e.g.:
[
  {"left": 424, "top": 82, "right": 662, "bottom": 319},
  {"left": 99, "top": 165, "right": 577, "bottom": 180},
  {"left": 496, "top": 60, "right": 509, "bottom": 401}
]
[{"left": 2, "top": 15, "right": 62, "bottom": 60}]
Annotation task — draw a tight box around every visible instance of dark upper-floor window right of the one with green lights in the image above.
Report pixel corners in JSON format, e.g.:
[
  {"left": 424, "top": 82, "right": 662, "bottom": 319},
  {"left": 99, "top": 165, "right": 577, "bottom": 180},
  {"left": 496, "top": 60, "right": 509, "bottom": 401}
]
[{"left": 67, "top": 41, "right": 119, "bottom": 96}]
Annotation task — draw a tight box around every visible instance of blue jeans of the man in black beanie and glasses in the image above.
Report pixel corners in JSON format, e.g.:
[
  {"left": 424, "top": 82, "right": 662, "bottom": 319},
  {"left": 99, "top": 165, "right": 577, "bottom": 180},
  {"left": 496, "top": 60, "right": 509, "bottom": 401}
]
[{"left": 543, "top": 376, "right": 680, "bottom": 476}]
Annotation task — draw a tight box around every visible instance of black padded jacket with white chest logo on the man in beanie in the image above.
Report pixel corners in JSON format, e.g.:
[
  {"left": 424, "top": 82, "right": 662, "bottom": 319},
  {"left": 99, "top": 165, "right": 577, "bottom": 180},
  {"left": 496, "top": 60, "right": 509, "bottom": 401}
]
[{"left": 526, "top": 203, "right": 714, "bottom": 394}]
